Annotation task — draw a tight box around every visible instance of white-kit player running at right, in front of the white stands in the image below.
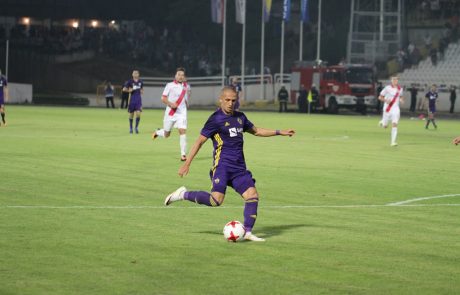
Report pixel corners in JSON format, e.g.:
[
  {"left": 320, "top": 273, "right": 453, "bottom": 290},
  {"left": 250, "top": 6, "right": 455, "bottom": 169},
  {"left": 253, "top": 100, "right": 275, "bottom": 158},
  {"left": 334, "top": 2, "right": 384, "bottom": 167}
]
[{"left": 379, "top": 76, "right": 404, "bottom": 146}]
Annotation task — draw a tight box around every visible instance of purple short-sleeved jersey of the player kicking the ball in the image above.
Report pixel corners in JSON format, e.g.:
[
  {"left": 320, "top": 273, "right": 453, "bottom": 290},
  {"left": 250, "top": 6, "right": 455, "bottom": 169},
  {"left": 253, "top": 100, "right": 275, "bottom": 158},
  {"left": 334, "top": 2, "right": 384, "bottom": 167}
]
[{"left": 201, "top": 108, "right": 254, "bottom": 170}]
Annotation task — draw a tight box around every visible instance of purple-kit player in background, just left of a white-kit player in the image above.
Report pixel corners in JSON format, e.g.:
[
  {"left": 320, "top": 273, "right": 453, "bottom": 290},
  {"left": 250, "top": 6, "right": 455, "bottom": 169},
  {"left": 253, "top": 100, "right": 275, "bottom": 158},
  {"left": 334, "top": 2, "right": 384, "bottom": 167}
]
[{"left": 123, "top": 70, "right": 144, "bottom": 133}]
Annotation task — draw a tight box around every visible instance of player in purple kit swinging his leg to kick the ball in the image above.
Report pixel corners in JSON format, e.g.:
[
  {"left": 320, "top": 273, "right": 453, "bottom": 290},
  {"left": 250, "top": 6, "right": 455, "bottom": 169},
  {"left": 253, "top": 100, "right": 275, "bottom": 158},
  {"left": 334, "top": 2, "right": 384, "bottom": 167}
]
[{"left": 164, "top": 86, "right": 295, "bottom": 242}]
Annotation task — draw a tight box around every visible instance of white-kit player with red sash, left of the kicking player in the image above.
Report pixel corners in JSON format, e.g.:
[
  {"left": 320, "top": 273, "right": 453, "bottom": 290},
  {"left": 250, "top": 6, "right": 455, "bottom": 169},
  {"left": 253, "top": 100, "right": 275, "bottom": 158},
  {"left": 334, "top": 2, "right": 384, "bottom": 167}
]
[{"left": 152, "top": 68, "right": 191, "bottom": 161}]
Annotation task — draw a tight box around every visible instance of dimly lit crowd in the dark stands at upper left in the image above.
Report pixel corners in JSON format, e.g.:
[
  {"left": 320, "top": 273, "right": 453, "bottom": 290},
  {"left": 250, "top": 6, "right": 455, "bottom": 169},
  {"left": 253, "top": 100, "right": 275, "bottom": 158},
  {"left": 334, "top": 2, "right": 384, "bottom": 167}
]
[{"left": 0, "top": 22, "right": 239, "bottom": 76}]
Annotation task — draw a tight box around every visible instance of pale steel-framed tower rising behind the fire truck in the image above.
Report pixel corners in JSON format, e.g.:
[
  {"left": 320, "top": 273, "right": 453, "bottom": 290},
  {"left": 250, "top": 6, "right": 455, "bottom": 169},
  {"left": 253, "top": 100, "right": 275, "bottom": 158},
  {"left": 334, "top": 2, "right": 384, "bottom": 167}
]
[{"left": 347, "top": 0, "right": 403, "bottom": 64}]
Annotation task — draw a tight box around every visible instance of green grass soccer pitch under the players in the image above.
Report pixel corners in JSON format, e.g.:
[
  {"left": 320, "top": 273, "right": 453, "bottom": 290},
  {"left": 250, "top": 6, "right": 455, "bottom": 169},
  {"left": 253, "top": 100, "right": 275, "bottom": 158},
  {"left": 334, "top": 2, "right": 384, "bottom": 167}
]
[{"left": 0, "top": 106, "right": 460, "bottom": 295}]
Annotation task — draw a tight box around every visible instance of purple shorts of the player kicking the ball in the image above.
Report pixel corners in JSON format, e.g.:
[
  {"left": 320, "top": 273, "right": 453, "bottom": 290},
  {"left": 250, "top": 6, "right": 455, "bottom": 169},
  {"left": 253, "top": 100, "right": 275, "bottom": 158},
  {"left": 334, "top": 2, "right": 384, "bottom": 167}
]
[{"left": 209, "top": 165, "right": 256, "bottom": 195}]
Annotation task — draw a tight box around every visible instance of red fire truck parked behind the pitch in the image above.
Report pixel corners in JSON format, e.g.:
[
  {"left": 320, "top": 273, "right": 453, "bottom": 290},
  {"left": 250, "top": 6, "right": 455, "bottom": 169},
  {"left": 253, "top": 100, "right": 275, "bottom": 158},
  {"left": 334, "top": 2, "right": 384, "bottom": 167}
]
[{"left": 291, "top": 62, "right": 377, "bottom": 114}]
